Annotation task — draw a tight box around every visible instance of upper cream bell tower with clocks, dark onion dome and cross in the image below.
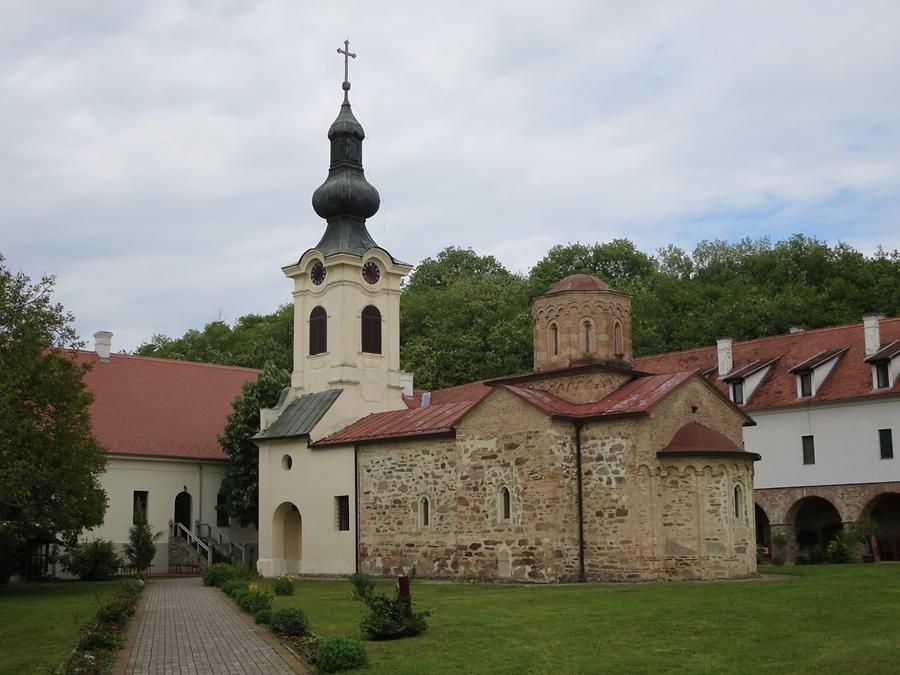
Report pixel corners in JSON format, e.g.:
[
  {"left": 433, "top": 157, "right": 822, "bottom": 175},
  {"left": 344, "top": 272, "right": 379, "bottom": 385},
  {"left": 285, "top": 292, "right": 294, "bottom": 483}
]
[{"left": 283, "top": 41, "right": 412, "bottom": 417}]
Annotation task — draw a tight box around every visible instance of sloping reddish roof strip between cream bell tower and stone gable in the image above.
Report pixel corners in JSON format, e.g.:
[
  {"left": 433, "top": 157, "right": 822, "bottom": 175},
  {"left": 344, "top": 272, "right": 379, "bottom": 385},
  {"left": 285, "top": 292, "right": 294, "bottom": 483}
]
[{"left": 314, "top": 401, "right": 476, "bottom": 446}]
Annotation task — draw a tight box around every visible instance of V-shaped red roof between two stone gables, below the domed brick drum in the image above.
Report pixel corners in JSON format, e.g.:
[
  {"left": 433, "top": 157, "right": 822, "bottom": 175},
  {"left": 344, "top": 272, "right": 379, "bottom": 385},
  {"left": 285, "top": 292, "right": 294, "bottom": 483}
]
[{"left": 502, "top": 373, "right": 695, "bottom": 418}]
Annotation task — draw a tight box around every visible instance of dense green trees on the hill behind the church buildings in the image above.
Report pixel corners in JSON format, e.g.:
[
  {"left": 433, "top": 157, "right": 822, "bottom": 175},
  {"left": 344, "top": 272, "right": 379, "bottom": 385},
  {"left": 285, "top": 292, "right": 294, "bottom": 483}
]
[{"left": 137, "top": 235, "right": 900, "bottom": 389}]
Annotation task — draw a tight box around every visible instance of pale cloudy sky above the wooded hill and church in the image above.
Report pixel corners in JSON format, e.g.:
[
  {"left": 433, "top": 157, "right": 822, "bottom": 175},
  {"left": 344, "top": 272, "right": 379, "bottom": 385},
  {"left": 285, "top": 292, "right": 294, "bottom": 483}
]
[{"left": 0, "top": 0, "right": 900, "bottom": 351}]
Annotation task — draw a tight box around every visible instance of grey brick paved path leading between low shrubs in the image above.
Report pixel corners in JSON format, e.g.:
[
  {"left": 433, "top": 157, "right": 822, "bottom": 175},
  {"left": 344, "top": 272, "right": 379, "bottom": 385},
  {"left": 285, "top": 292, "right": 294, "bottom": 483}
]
[{"left": 125, "top": 578, "right": 295, "bottom": 675}]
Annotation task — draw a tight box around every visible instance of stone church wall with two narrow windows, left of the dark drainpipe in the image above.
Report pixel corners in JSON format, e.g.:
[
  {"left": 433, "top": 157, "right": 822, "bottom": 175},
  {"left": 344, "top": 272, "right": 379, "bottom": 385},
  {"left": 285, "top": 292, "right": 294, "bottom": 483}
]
[{"left": 359, "top": 391, "right": 578, "bottom": 582}]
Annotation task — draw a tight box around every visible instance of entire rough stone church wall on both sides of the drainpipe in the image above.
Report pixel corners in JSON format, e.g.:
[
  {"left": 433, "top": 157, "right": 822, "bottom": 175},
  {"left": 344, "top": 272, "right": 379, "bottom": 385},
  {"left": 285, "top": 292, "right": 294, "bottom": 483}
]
[{"left": 358, "top": 381, "right": 755, "bottom": 582}]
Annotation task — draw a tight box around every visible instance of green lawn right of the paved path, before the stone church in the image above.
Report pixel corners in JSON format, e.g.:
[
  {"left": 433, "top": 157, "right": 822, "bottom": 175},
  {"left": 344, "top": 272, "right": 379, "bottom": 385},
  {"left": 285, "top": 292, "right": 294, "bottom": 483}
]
[{"left": 262, "top": 564, "right": 900, "bottom": 675}]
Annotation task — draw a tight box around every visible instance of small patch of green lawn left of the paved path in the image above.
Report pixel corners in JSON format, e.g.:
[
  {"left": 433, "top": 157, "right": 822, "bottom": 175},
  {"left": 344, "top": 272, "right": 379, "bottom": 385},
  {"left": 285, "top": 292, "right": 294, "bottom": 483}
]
[{"left": 0, "top": 581, "right": 119, "bottom": 675}]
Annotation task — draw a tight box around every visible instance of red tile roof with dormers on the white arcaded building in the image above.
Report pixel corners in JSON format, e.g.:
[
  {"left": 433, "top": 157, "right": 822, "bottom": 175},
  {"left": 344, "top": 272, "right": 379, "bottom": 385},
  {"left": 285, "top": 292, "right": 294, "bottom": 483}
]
[{"left": 634, "top": 317, "right": 900, "bottom": 410}]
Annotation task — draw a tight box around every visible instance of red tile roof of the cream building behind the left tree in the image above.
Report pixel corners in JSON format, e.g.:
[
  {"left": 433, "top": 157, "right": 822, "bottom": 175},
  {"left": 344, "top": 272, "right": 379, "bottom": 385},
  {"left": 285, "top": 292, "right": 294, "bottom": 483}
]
[{"left": 76, "top": 351, "right": 259, "bottom": 459}]
